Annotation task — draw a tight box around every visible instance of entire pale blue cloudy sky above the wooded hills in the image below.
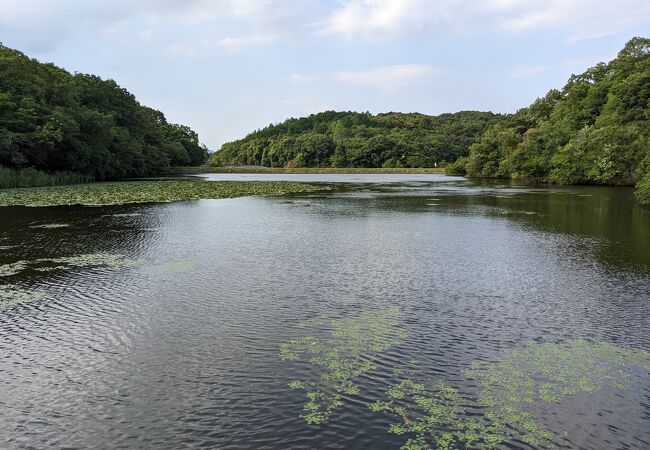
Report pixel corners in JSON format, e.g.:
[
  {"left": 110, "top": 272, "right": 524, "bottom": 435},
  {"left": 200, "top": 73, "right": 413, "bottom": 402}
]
[{"left": 0, "top": 0, "right": 650, "bottom": 150}]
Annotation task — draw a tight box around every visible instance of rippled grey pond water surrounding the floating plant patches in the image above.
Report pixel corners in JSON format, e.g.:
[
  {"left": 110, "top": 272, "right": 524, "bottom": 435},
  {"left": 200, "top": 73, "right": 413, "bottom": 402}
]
[{"left": 0, "top": 174, "right": 650, "bottom": 449}]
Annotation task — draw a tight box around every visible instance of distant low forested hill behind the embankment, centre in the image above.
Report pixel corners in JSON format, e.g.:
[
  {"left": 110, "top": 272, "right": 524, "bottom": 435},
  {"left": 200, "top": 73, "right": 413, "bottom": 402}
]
[{"left": 211, "top": 111, "right": 504, "bottom": 167}]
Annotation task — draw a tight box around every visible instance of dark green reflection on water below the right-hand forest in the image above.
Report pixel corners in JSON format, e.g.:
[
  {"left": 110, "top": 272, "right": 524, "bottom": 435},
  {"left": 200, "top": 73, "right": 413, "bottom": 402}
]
[{"left": 302, "top": 180, "right": 650, "bottom": 270}]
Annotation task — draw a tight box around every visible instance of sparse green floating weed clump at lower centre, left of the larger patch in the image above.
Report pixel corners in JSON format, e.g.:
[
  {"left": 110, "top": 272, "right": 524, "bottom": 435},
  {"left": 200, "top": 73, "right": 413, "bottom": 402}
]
[{"left": 280, "top": 306, "right": 407, "bottom": 424}]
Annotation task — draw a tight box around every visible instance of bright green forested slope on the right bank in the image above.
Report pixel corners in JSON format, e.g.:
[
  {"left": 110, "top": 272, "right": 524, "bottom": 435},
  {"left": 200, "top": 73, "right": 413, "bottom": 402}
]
[{"left": 448, "top": 38, "right": 650, "bottom": 203}]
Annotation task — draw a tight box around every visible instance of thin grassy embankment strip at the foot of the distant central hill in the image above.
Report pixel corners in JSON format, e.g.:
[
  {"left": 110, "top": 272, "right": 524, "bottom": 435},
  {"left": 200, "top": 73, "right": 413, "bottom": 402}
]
[{"left": 166, "top": 166, "right": 445, "bottom": 176}]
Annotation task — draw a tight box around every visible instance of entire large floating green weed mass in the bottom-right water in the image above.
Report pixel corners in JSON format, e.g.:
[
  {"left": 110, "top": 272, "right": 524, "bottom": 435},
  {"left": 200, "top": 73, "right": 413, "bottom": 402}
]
[{"left": 369, "top": 340, "right": 650, "bottom": 450}]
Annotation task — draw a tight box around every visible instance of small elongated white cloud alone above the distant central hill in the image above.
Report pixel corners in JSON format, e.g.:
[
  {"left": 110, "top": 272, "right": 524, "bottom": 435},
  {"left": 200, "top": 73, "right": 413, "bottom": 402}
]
[{"left": 335, "top": 64, "right": 439, "bottom": 89}]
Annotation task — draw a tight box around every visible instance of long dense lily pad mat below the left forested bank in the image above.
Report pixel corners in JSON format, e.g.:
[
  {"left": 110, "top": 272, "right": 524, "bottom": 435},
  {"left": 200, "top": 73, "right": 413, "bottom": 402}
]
[{"left": 0, "top": 180, "right": 326, "bottom": 206}]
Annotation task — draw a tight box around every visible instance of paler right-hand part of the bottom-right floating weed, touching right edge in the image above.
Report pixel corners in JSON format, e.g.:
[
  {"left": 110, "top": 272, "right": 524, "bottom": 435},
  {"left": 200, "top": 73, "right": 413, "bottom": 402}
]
[{"left": 465, "top": 340, "right": 650, "bottom": 447}]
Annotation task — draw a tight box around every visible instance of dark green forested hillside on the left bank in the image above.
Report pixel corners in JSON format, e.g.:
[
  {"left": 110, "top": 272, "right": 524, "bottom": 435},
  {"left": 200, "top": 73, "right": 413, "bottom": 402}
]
[{"left": 0, "top": 44, "right": 207, "bottom": 180}]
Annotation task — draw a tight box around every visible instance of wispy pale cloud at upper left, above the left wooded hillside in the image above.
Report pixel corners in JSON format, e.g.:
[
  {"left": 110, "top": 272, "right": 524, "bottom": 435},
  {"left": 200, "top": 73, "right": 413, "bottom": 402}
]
[{"left": 0, "top": 0, "right": 308, "bottom": 51}]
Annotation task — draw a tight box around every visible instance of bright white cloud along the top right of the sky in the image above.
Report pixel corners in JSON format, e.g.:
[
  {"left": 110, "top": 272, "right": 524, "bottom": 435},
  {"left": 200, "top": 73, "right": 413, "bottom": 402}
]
[{"left": 319, "top": 0, "right": 650, "bottom": 41}]
